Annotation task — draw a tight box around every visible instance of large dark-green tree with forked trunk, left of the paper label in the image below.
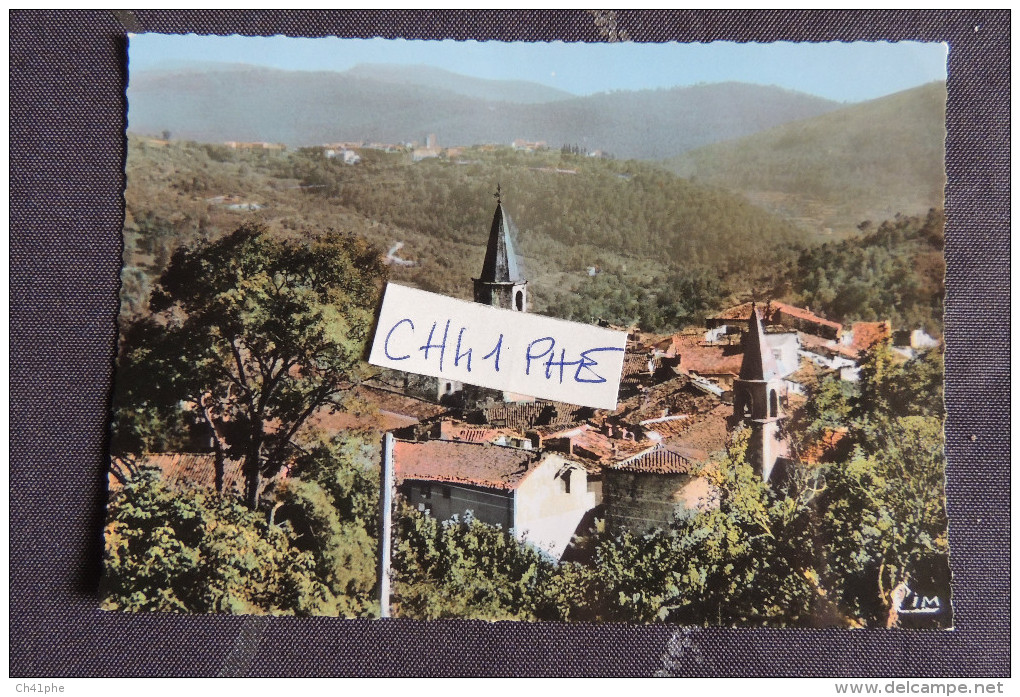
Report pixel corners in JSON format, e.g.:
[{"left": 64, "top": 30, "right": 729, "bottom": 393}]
[{"left": 113, "top": 223, "right": 385, "bottom": 508}]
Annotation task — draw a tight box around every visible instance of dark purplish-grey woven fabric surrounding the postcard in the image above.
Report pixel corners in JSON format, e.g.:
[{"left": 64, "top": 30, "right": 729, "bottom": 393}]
[{"left": 10, "top": 11, "right": 1010, "bottom": 677}]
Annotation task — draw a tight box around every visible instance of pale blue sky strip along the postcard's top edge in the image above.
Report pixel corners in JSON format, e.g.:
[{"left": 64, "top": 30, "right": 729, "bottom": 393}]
[{"left": 129, "top": 34, "right": 948, "bottom": 102}]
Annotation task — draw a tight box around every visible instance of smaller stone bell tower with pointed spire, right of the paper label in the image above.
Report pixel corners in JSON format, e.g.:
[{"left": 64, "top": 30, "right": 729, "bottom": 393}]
[{"left": 733, "top": 303, "right": 789, "bottom": 482}]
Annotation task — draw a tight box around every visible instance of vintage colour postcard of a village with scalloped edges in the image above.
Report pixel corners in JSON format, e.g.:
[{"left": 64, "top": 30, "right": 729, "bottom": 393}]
[{"left": 102, "top": 35, "right": 953, "bottom": 629}]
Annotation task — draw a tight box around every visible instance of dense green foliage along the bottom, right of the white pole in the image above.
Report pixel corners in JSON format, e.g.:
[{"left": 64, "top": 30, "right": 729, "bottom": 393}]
[{"left": 395, "top": 344, "right": 951, "bottom": 627}]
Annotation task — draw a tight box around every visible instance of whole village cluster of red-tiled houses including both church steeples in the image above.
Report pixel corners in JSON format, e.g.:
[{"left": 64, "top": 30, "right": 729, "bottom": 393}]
[{"left": 362, "top": 195, "right": 936, "bottom": 558}]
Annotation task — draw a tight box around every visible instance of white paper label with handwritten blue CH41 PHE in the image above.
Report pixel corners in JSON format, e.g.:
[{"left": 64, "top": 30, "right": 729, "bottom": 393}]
[{"left": 368, "top": 284, "right": 627, "bottom": 409}]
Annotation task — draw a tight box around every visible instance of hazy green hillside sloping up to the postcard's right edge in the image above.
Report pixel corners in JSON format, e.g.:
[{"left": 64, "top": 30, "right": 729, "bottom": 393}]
[{"left": 666, "top": 82, "right": 946, "bottom": 234}]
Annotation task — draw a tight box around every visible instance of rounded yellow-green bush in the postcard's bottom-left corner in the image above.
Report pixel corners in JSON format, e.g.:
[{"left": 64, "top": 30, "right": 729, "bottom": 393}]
[{"left": 103, "top": 470, "right": 336, "bottom": 615}]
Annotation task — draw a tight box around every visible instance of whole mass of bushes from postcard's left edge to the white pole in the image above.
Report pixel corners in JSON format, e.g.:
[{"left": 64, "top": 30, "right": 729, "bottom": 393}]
[{"left": 103, "top": 437, "right": 378, "bottom": 616}]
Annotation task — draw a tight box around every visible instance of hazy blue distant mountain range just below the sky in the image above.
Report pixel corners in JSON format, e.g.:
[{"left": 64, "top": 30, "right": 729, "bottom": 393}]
[{"left": 128, "top": 65, "right": 838, "bottom": 159}]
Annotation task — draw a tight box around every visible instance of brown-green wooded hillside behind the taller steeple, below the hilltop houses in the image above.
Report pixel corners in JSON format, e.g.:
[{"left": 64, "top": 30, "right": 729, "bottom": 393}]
[{"left": 117, "top": 137, "right": 805, "bottom": 329}]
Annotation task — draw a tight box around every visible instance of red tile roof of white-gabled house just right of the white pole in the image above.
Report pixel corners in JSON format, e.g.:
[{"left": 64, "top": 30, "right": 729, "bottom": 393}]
[{"left": 394, "top": 441, "right": 539, "bottom": 491}]
